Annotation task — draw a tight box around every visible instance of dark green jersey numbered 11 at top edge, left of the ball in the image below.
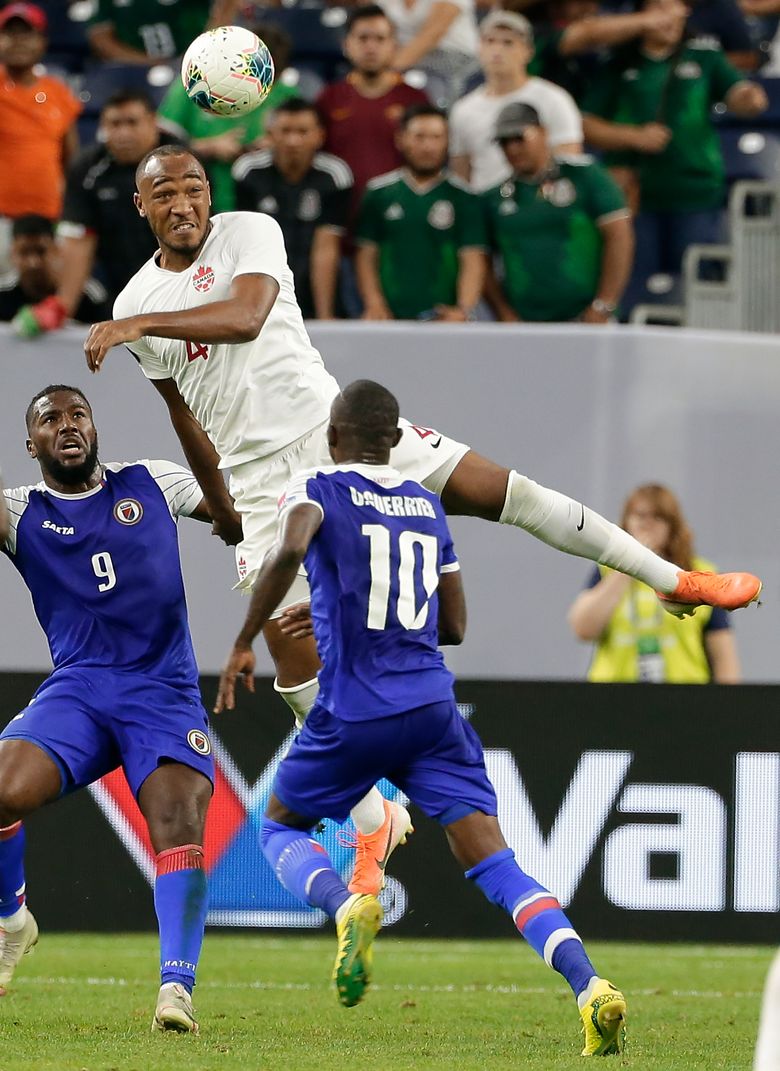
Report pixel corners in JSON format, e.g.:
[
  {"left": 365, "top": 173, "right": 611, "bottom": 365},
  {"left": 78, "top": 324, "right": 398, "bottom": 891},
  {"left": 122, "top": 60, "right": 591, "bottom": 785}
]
[{"left": 90, "top": 0, "right": 211, "bottom": 59}]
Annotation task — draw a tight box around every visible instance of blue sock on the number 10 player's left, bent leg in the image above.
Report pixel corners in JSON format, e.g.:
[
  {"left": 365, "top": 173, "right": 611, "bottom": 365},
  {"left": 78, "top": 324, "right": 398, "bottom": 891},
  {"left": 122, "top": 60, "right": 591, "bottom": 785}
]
[{"left": 260, "top": 818, "right": 350, "bottom": 918}]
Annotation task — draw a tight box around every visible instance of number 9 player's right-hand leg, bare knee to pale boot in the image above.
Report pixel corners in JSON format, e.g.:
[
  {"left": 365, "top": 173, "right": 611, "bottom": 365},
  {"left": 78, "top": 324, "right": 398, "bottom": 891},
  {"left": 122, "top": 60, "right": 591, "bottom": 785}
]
[{"left": 138, "top": 763, "right": 212, "bottom": 1034}]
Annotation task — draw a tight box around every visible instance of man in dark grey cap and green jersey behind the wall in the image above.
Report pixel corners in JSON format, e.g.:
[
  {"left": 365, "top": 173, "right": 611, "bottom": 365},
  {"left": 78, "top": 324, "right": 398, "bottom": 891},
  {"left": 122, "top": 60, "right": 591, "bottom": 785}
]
[{"left": 482, "top": 102, "right": 633, "bottom": 323}]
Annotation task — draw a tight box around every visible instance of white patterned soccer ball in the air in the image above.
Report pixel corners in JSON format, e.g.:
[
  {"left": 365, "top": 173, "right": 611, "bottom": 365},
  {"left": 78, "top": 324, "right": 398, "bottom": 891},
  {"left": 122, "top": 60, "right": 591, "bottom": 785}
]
[{"left": 181, "top": 26, "right": 273, "bottom": 116}]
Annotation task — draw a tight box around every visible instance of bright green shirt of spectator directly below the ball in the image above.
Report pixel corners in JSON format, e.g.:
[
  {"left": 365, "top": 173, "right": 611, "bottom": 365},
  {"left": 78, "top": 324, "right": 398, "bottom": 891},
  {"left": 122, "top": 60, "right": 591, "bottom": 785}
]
[{"left": 158, "top": 78, "right": 298, "bottom": 212}]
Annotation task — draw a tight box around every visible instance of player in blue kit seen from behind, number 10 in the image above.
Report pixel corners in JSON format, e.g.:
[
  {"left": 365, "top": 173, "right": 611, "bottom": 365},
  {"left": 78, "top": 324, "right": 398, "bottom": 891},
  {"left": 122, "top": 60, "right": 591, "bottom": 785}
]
[{"left": 218, "top": 380, "right": 626, "bottom": 1056}]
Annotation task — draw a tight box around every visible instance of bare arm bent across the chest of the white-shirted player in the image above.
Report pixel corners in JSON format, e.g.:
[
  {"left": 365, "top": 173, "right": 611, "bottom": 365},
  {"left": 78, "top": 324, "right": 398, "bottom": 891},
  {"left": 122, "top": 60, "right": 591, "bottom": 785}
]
[{"left": 84, "top": 274, "right": 279, "bottom": 372}]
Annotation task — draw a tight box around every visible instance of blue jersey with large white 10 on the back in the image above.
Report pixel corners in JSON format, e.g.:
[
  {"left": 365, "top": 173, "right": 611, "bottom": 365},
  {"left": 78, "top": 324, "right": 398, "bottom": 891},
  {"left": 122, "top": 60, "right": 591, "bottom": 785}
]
[{"left": 280, "top": 465, "right": 460, "bottom": 721}]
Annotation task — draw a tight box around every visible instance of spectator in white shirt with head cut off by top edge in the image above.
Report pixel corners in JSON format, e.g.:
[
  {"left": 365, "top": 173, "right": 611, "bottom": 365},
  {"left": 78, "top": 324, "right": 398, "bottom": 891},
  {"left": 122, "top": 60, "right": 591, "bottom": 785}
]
[{"left": 381, "top": 0, "right": 479, "bottom": 108}]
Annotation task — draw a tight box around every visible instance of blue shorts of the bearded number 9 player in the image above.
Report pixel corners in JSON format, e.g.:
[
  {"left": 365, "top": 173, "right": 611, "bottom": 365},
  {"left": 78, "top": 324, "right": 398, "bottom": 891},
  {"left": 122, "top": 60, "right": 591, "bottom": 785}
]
[{"left": 0, "top": 668, "right": 214, "bottom": 797}]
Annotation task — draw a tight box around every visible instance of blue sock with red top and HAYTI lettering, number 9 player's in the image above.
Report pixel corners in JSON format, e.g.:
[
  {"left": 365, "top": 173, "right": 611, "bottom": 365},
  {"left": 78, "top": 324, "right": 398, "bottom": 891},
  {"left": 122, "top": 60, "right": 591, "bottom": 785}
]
[{"left": 154, "top": 844, "right": 209, "bottom": 993}]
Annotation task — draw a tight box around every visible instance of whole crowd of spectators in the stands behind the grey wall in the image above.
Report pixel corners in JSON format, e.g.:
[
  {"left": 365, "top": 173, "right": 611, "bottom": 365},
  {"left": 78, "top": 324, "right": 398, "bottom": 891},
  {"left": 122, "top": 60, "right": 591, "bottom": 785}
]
[{"left": 0, "top": 0, "right": 780, "bottom": 337}]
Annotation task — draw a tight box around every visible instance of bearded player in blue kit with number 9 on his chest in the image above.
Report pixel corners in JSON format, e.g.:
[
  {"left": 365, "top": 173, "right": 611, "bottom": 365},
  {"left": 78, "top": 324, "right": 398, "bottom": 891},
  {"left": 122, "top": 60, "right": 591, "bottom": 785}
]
[{"left": 0, "top": 386, "right": 240, "bottom": 1032}]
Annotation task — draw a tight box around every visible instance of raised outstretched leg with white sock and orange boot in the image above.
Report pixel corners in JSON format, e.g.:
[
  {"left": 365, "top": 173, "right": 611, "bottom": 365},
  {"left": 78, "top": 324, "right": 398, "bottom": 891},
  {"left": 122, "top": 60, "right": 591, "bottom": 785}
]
[{"left": 441, "top": 451, "right": 761, "bottom": 613}]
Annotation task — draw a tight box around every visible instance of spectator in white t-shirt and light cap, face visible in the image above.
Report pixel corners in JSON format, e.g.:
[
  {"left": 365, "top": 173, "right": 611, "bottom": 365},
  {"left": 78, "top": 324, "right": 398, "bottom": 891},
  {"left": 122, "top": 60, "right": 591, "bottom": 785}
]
[{"left": 450, "top": 11, "right": 583, "bottom": 193}]
